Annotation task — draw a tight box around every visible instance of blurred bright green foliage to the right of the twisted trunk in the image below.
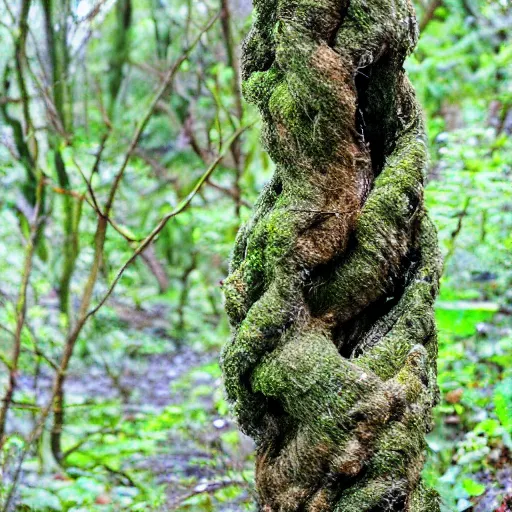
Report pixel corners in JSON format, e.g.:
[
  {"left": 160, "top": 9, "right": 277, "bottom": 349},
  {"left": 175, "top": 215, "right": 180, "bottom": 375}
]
[{"left": 409, "top": 2, "right": 512, "bottom": 511}]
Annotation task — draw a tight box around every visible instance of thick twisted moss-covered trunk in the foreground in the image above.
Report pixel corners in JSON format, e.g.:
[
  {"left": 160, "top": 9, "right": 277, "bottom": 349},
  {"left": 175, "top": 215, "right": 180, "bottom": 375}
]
[{"left": 222, "top": 0, "right": 441, "bottom": 512}]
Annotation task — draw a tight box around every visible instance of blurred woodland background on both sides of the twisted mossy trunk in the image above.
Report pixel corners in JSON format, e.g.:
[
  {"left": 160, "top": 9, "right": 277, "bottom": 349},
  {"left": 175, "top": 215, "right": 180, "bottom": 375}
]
[{"left": 0, "top": 0, "right": 512, "bottom": 512}]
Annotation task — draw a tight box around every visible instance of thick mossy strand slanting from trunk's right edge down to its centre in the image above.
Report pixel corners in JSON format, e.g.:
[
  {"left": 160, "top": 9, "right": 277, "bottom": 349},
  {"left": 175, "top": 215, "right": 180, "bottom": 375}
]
[{"left": 311, "top": 119, "right": 427, "bottom": 320}]
